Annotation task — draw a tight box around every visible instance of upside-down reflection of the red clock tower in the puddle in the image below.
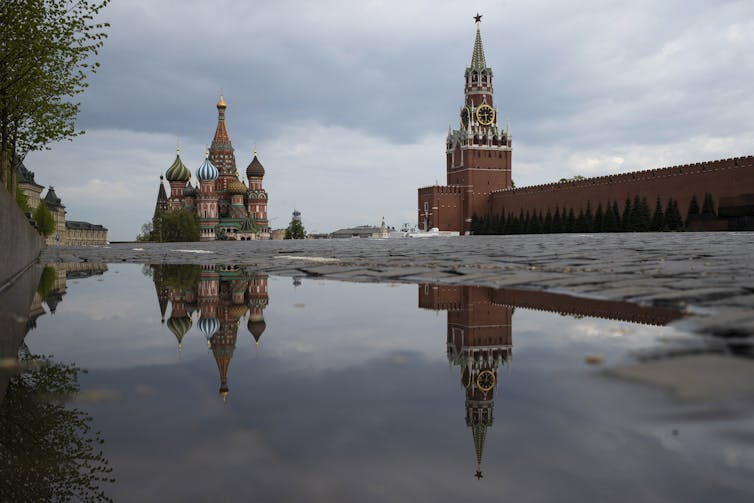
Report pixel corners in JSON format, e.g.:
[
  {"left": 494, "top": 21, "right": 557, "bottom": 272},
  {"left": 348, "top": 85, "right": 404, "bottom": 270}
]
[{"left": 419, "top": 284, "right": 513, "bottom": 479}]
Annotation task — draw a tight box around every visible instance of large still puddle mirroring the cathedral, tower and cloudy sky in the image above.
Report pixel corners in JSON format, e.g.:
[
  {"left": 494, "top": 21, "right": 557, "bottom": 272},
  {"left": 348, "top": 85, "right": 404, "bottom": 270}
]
[{"left": 0, "top": 264, "right": 754, "bottom": 502}]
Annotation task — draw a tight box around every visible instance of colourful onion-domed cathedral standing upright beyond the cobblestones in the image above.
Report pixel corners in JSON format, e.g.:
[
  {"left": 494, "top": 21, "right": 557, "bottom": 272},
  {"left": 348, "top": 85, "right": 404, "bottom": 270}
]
[{"left": 152, "top": 96, "right": 270, "bottom": 241}]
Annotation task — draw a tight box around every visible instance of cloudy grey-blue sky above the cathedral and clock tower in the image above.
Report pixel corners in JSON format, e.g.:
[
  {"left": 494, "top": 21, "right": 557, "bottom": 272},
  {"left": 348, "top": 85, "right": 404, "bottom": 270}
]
[{"left": 26, "top": 0, "right": 754, "bottom": 240}]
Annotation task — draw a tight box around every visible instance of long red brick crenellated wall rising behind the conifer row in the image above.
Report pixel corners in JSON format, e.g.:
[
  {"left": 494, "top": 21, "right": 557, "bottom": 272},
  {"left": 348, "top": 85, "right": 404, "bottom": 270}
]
[{"left": 490, "top": 156, "right": 754, "bottom": 217}]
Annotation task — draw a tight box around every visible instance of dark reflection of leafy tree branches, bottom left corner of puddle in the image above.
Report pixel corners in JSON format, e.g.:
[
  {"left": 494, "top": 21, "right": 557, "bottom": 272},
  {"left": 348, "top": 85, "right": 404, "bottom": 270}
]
[{"left": 0, "top": 348, "right": 115, "bottom": 501}]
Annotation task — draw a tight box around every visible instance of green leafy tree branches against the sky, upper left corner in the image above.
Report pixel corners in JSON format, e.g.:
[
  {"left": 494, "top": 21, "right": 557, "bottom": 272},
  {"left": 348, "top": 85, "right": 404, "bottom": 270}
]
[{"left": 0, "top": 0, "right": 110, "bottom": 186}]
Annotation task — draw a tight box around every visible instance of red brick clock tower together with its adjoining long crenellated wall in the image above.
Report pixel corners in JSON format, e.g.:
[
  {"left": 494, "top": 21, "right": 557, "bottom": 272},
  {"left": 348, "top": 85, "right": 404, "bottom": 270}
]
[{"left": 417, "top": 16, "right": 754, "bottom": 234}]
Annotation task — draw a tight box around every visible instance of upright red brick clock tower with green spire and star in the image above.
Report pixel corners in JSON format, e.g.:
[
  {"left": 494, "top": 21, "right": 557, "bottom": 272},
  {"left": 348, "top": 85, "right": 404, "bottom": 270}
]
[{"left": 446, "top": 14, "right": 512, "bottom": 232}]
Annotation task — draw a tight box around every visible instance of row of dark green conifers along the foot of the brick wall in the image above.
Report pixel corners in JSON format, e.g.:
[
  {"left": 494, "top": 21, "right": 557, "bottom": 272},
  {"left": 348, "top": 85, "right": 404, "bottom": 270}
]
[{"left": 471, "top": 193, "right": 715, "bottom": 234}]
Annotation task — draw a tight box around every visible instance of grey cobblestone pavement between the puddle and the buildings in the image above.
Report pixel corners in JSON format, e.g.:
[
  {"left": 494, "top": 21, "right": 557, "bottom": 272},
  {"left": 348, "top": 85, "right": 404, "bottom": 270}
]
[{"left": 42, "top": 233, "right": 754, "bottom": 336}]
